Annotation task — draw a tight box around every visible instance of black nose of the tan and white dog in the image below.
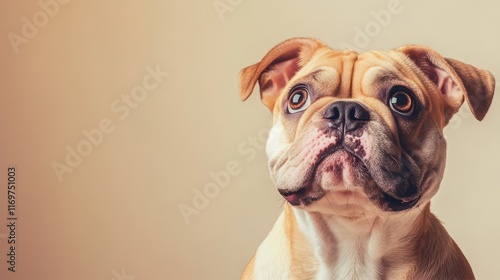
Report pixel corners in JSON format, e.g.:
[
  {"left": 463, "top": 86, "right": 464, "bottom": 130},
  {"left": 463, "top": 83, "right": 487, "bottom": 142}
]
[{"left": 323, "top": 101, "right": 370, "bottom": 132}]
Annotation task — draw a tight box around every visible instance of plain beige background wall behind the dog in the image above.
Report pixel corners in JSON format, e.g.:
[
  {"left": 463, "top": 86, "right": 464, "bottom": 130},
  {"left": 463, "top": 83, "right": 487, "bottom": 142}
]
[{"left": 0, "top": 0, "right": 500, "bottom": 280}]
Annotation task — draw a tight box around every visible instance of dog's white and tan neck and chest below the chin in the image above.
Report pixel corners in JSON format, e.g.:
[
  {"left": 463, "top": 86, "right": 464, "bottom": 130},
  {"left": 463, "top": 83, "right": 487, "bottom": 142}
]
[{"left": 292, "top": 204, "right": 431, "bottom": 279}]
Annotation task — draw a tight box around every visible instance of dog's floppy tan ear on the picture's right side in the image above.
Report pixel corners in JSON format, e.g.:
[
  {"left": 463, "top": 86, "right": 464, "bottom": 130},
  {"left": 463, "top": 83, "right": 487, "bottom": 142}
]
[{"left": 397, "top": 46, "right": 495, "bottom": 123}]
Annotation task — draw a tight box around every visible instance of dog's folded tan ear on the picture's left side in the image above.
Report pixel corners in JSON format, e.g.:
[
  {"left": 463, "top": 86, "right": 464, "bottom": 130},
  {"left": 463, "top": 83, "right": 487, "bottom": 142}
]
[{"left": 239, "top": 38, "right": 323, "bottom": 111}]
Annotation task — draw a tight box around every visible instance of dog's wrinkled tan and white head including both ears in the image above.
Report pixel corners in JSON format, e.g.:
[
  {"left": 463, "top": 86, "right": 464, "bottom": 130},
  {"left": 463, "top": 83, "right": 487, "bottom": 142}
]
[{"left": 240, "top": 38, "right": 494, "bottom": 216}]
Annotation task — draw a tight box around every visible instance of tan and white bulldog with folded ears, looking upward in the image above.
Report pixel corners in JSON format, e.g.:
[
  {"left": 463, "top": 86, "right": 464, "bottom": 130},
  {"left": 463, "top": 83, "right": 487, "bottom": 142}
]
[{"left": 239, "top": 38, "right": 495, "bottom": 280}]
